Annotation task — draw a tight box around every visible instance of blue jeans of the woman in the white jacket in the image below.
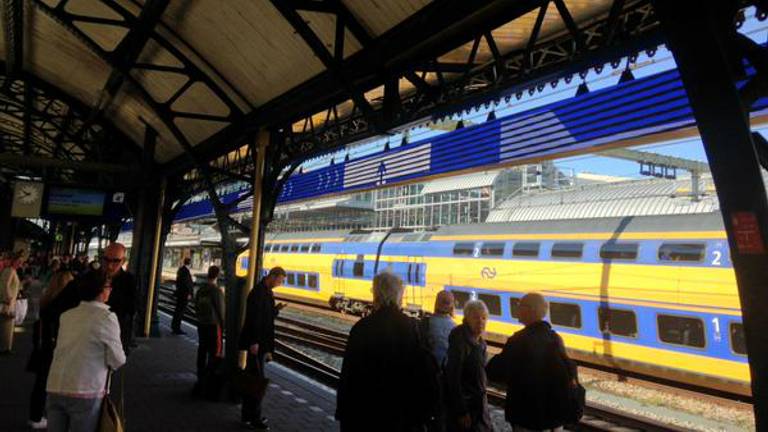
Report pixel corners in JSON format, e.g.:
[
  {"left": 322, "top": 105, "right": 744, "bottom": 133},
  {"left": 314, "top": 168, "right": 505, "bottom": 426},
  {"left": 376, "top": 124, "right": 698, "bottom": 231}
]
[{"left": 47, "top": 393, "right": 104, "bottom": 432}]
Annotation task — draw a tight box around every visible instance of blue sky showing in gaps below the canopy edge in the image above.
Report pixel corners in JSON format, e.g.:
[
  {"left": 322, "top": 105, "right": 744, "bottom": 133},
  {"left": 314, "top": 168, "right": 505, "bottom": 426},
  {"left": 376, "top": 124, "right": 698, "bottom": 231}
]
[{"left": 305, "top": 8, "right": 768, "bottom": 181}]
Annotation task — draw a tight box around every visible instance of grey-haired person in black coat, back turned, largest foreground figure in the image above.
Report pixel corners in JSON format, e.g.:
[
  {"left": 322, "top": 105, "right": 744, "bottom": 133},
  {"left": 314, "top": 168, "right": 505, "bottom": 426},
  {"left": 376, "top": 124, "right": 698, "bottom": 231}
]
[{"left": 336, "top": 272, "right": 439, "bottom": 432}]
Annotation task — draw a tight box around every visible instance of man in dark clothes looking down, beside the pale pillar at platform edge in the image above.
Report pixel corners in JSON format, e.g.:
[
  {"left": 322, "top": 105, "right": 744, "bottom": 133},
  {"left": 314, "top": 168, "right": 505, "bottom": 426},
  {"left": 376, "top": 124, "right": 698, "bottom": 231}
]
[{"left": 239, "top": 267, "right": 285, "bottom": 430}]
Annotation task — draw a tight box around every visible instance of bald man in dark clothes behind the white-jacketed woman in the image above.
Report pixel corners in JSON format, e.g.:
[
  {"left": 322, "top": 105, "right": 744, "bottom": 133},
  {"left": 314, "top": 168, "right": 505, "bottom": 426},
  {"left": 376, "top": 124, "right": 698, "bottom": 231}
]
[{"left": 101, "top": 243, "right": 137, "bottom": 353}]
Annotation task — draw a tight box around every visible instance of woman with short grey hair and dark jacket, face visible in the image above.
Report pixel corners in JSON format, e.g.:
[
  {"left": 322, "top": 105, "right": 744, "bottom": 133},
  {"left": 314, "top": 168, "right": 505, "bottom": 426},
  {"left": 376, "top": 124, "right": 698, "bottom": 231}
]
[{"left": 445, "top": 300, "right": 493, "bottom": 432}]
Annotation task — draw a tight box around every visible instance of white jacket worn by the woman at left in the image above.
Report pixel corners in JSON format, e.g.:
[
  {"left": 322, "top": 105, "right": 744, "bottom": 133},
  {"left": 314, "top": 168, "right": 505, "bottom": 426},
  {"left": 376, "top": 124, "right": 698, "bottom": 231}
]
[{"left": 46, "top": 301, "right": 125, "bottom": 398}]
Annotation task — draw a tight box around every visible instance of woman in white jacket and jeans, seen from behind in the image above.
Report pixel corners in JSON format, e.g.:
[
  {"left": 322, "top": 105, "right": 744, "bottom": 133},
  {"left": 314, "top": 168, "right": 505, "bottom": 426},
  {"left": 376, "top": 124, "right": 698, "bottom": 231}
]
[{"left": 46, "top": 271, "right": 125, "bottom": 432}]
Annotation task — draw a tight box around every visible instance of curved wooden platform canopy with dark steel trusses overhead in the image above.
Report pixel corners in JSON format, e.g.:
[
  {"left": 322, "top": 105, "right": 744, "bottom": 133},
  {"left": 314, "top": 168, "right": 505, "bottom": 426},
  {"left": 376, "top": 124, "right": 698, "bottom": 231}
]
[{"left": 0, "top": 0, "right": 660, "bottom": 187}]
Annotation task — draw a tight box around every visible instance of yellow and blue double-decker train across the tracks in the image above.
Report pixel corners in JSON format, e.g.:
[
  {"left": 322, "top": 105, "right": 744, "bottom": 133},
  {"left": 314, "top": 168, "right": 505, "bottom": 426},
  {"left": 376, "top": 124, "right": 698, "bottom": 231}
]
[{"left": 238, "top": 213, "right": 749, "bottom": 395}]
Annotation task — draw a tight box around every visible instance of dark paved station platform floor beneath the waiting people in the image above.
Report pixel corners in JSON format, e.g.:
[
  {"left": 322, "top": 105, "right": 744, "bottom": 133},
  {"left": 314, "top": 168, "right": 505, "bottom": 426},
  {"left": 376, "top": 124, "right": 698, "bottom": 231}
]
[{"left": 0, "top": 315, "right": 339, "bottom": 432}]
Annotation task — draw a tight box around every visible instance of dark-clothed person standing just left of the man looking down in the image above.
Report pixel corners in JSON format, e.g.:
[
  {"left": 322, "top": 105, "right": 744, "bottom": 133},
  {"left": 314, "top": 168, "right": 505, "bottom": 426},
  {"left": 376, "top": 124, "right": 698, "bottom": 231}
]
[{"left": 194, "top": 266, "right": 224, "bottom": 394}]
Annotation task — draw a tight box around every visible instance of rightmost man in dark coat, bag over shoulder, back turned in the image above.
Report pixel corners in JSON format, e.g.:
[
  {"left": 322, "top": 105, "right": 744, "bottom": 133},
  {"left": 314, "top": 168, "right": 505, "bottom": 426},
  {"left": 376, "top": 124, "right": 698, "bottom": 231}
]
[{"left": 486, "top": 293, "right": 578, "bottom": 431}]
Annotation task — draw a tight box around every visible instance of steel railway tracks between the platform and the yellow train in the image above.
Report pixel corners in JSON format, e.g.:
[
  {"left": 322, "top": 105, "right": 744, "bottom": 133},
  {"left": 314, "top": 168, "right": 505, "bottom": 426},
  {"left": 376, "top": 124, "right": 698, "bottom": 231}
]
[{"left": 158, "top": 287, "right": 744, "bottom": 432}]
